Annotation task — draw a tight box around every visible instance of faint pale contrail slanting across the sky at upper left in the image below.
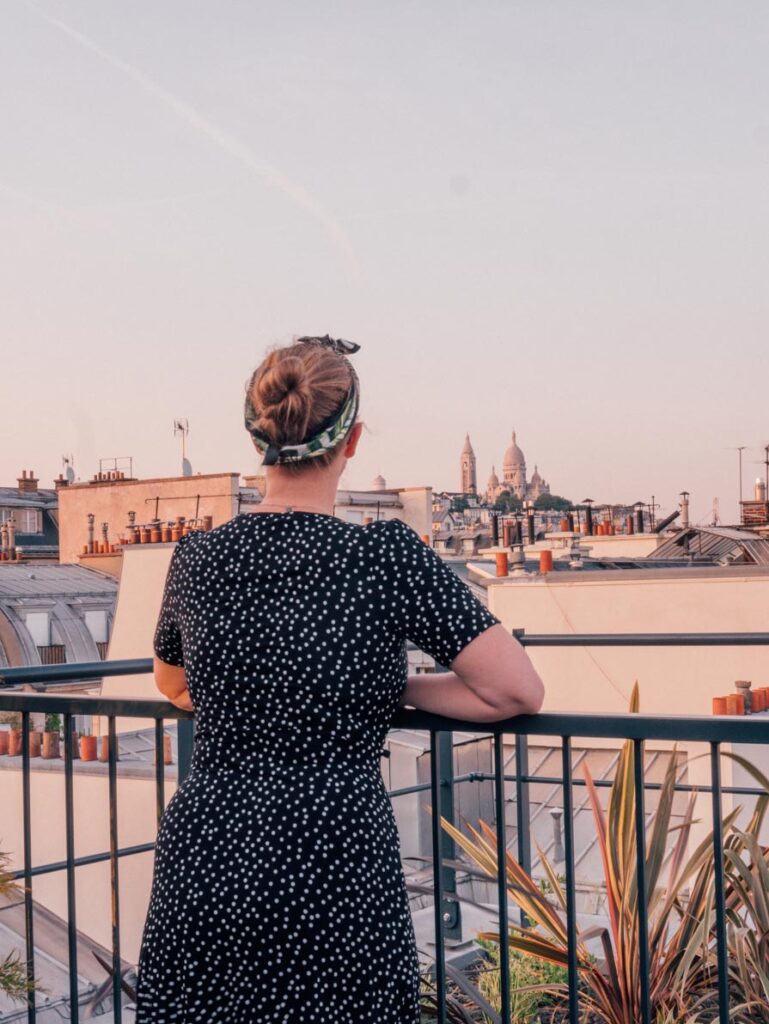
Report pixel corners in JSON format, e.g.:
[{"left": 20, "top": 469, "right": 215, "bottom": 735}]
[{"left": 30, "top": 4, "right": 355, "bottom": 263}]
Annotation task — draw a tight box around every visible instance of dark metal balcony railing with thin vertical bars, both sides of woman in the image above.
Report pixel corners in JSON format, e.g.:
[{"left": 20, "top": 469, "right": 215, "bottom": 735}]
[{"left": 0, "top": 632, "right": 769, "bottom": 1024}]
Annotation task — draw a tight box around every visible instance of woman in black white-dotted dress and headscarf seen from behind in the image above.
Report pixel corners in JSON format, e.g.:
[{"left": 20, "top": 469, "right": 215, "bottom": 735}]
[{"left": 136, "top": 336, "right": 543, "bottom": 1024}]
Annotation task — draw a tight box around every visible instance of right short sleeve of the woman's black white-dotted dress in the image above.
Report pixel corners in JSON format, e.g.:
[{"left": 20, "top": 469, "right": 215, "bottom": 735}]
[{"left": 376, "top": 519, "right": 500, "bottom": 666}]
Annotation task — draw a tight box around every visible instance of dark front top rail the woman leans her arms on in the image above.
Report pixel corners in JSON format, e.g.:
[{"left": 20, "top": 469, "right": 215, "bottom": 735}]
[{"left": 0, "top": 691, "right": 769, "bottom": 743}]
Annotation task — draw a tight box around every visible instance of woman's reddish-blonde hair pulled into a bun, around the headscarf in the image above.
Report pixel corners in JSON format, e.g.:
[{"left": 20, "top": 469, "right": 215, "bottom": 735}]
[{"left": 246, "top": 341, "right": 356, "bottom": 472}]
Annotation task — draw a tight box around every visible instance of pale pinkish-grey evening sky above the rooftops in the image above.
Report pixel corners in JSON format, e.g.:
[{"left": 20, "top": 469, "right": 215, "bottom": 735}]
[{"left": 0, "top": 0, "right": 769, "bottom": 522}]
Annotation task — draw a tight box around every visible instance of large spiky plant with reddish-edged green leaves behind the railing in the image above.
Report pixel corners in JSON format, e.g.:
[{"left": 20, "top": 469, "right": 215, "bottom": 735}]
[{"left": 434, "top": 686, "right": 760, "bottom": 1024}]
